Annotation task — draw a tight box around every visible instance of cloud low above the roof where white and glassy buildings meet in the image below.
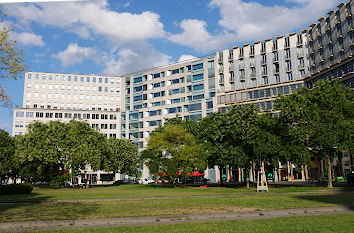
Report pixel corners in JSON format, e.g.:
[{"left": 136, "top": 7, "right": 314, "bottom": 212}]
[{"left": 103, "top": 43, "right": 171, "bottom": 75}]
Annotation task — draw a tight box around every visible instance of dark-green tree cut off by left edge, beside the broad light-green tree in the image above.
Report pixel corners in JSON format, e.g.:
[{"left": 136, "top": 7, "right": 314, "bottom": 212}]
[{"left": 0, "top": 129, "right": 19, "bottom": 184}]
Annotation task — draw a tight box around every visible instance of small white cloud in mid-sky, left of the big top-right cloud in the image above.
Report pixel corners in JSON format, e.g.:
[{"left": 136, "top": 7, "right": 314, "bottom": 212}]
[{"left": 168, "top": 19, "right": 235, "bottom": 52}]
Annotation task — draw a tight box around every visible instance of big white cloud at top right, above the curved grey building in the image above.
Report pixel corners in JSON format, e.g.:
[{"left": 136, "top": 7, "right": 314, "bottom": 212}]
[{"left": 209, "top": 0, "right": 339, "bottom": 42}]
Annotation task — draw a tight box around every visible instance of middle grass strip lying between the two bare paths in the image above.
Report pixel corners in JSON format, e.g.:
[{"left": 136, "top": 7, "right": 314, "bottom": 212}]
[{"left": 0, "top": 192, "right": 354, "bottom": 221}]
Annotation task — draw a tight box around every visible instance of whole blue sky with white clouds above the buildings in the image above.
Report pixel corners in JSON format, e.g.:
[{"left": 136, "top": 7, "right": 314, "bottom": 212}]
[{"left": 0, "top": 0, "right": 341, "bottom": 132}]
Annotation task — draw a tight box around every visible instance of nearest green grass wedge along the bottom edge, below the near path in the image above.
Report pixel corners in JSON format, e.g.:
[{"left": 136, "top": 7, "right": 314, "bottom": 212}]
[{"left": 41, "top": 214, "right": 354, "bottom": 233}]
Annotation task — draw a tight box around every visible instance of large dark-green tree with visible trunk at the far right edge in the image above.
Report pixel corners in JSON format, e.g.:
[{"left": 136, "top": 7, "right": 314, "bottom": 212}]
[{"left": 276, "top": 80, "right": 354, "bottom": 188}]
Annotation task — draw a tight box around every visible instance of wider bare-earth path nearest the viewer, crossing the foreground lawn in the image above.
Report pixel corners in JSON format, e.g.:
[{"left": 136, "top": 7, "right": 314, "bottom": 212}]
[{"left": 0, "top": 206, "right": 354, "bottom": 232}]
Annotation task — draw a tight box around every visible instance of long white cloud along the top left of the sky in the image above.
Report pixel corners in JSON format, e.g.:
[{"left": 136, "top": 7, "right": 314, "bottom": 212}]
[{"left": 6, "top": 0, "right": 165, "bottom": 42}]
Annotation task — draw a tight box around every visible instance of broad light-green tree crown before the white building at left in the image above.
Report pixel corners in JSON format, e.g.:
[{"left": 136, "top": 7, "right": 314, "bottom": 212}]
[{"left": 16, "top": 120, "right": 107, "bottom": 184}]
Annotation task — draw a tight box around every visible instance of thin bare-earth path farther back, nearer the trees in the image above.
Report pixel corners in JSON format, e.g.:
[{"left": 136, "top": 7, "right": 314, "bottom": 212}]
[{"left": 0, "top": 190, "right": 354, "bottom": 205}]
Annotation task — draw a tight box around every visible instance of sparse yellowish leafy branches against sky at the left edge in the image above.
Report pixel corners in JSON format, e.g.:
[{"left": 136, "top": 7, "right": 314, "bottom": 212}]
[{"left": 0, "top": 19, "right": 26, "bottom": 106}]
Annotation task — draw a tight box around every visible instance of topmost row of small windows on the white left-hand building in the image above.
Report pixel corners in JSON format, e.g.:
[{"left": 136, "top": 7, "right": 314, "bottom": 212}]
[{"left": 27, "top": 73, "right": 120, "bottom": 84}]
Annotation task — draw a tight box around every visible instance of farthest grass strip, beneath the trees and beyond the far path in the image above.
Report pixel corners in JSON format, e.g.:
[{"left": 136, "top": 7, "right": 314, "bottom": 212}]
[{"left": 0, "top": 185, "right": 354, "bottom": 201}]
